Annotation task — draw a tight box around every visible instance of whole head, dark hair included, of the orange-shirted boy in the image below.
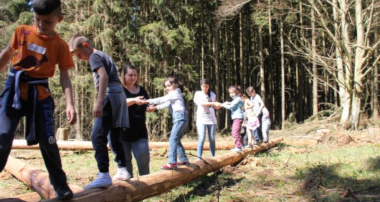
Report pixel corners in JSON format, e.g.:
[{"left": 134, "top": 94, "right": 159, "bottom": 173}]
[{"left": 33, "top": 0, "right": 63, "bottom": 36}]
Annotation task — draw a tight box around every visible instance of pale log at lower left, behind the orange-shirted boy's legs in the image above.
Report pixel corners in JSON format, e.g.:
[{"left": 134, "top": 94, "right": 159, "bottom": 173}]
[{"left": 4, "top": 156, "right": 83, "bottom": 199}]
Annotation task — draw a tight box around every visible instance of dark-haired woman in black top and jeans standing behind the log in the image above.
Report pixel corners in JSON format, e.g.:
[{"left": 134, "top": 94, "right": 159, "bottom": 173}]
[{"left": 118, "top": 65, "right": 150, "bottom": 177}]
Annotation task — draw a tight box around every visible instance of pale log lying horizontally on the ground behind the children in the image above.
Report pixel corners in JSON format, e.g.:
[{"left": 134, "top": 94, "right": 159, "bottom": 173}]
[{"left": 12, "top": 140, "right": 235, "bottom": 151}]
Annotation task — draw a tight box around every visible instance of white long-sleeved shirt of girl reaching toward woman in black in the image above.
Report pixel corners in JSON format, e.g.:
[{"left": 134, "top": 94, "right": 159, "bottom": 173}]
[{"left": 148, "top": 88, "right": 185, "bottom": 112}]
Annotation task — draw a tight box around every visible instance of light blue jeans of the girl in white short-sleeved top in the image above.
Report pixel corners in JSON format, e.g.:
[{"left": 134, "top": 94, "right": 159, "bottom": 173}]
[{"left": 197, "top": 123, "right": 216, "bottom": 159}]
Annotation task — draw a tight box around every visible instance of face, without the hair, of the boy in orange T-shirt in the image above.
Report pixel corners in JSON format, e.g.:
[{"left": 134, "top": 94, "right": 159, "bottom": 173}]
[{"left": 34, "top": 12, "right": 63, "bottom": 36}]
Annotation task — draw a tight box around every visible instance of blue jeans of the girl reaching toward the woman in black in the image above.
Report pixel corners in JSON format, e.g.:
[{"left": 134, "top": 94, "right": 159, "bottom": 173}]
[{"left": 168, "top": 111, "right": 189, "bottom": 164}]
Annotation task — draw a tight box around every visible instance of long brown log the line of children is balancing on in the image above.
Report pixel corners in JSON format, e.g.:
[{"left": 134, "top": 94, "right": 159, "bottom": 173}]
[{"left": 43, "top": 138, "right": 282, "bottom": 202}]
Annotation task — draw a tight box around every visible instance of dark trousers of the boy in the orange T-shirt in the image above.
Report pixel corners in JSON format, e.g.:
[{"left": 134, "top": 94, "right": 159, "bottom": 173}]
[{"left": 0, "top": 92, "right": 67, "bottom": 187}]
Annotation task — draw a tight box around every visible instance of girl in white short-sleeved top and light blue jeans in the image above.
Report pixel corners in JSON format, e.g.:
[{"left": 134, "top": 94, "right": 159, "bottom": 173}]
[{"left": 194, "top": 79, "right": 220, "bottom": 161}]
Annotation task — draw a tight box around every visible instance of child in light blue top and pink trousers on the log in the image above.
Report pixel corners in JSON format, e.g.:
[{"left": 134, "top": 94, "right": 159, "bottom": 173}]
[{"left": 222, "top": 86, "right": 244, "bottom": 152}]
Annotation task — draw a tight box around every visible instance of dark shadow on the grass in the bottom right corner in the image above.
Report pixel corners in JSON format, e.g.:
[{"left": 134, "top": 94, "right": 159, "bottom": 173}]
[{"left": 294, "top": 163, "right": 380, "bottom": 202}]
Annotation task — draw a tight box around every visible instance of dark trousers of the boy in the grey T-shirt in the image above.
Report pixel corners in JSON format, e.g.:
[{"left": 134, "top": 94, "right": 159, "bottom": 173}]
[{"left": 91, "top": 102, "right": 126, "bottom": 173}]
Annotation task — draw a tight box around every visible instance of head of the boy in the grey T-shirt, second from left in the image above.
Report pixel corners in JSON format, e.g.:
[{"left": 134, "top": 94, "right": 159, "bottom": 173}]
[{"left": 68, "top": 34, "right": 94, "bottom": 61}]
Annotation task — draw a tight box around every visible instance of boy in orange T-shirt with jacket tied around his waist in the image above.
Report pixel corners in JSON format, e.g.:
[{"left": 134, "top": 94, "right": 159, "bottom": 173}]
[{"left": 0, "top": 0, "right": 76, "bottom": 199}]
